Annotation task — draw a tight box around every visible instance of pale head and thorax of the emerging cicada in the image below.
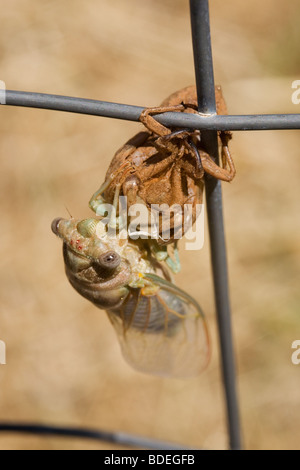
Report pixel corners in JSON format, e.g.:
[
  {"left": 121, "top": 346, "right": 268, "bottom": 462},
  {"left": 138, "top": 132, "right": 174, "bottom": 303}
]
[{"left": 52, "top": 219, "right": 132, "bottom": 309}]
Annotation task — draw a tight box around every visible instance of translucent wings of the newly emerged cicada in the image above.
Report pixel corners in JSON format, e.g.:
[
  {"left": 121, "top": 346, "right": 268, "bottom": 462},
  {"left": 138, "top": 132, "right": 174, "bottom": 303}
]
[{"left": 107, "top": 275, "right": 210, "bottom": 377}]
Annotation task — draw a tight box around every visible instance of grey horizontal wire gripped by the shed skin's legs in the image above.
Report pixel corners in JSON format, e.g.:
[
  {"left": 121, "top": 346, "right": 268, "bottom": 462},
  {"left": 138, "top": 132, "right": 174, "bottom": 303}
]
[{"left": 3, "top": 90, "right": 300, "bottom": 131}]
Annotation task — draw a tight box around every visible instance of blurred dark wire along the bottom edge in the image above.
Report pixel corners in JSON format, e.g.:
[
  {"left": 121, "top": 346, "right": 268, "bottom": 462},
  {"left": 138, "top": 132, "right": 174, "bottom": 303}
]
[{"left": 0, "top": 423, "right": 188, "bottom": 450}]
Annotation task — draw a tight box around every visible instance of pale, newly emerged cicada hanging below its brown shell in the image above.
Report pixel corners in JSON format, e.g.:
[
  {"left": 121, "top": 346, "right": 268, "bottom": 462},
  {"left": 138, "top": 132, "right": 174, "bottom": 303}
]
[{"left": 52, "top": 218, "right": 210, "bottom": 377}]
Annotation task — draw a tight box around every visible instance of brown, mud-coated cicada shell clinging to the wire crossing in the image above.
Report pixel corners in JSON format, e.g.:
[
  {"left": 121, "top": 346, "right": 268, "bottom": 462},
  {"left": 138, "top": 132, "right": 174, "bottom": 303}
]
[{"left": 90, "top": 86, "right": 235, "bottom": 245}]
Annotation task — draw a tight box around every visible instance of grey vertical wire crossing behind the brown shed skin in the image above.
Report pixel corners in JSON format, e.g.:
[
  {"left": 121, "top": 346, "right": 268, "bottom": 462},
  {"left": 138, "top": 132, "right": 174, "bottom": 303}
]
[{"left": 190, "top": 0, "right": 241, "bottom": 450}]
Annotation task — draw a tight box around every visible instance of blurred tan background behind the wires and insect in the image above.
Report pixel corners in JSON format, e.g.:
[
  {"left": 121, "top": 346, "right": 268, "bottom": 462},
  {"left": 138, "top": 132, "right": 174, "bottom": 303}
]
[{"left": 0, "top": 0, "right": 300, "bottom": 449}]
